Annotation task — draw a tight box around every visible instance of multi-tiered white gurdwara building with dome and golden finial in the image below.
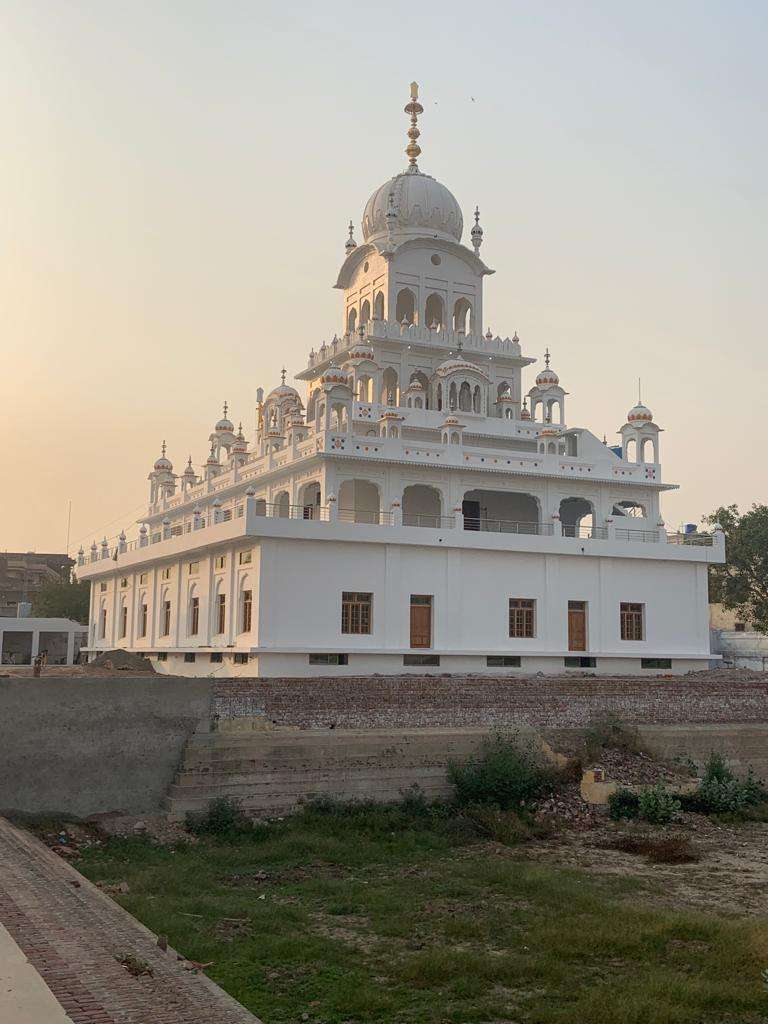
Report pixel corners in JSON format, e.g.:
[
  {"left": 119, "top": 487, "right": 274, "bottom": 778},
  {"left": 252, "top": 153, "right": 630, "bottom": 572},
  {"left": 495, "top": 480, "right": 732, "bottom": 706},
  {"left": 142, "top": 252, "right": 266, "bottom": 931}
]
[{"left": 77, "top": 84, "right": 724, "bottom": 676}]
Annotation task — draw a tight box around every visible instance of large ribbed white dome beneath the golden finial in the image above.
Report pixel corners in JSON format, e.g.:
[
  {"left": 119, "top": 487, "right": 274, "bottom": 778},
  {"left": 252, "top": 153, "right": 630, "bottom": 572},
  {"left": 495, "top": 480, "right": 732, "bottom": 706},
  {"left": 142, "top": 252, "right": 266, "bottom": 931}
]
[{"left": 362, "top": 168, "right": 464, "bottom": 242}]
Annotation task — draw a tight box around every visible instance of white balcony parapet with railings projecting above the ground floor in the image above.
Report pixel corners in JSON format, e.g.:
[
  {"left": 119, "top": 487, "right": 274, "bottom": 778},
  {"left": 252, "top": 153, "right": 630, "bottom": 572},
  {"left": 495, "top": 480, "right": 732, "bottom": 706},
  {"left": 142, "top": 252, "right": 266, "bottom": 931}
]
[{"left": 77, "top": 497, "right": 725, "bottom": 580}]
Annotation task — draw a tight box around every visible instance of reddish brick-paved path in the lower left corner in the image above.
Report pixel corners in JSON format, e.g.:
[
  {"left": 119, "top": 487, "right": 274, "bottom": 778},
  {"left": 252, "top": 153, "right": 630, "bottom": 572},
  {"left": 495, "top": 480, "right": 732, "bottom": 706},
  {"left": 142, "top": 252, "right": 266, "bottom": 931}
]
[{"left": 0, "top": 818, "right": 259, "bottom": 1024}]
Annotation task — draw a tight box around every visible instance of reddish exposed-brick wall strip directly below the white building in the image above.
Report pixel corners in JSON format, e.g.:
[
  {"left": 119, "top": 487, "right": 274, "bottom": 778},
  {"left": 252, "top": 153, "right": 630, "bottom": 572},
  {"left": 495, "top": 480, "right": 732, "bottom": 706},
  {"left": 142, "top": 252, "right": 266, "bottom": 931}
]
[{"left": 213, "top": 670, "right": 768, "bottom": 729}]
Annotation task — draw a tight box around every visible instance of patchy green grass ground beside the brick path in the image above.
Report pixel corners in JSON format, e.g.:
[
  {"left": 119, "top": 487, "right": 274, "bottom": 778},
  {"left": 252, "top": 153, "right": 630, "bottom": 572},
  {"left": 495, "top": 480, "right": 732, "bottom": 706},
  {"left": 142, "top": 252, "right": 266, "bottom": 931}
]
[{"left": 77, "top": 808, "right": 768, "bottom": 1024}]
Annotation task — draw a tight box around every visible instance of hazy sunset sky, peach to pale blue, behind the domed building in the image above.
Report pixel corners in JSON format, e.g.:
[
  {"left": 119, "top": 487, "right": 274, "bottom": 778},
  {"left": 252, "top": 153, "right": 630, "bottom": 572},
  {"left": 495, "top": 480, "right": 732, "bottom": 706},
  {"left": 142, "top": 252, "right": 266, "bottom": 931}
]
[{"left": 0, "top": 0, "right": 768, "bottom": 551}]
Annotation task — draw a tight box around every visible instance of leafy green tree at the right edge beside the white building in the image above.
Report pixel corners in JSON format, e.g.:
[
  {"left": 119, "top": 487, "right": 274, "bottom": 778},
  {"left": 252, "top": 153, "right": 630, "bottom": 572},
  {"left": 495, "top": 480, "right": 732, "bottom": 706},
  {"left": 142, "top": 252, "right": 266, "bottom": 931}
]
[{"left": 703, "top": 505, "right": 768, "bottom": 633}]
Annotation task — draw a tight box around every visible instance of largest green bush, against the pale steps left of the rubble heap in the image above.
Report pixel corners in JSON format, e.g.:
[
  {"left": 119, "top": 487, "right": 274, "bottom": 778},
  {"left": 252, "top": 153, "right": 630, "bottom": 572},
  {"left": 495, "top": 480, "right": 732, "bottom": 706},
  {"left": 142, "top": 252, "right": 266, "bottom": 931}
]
[{"left": 449, "top": 736, "right": 555, "bottom": 810}]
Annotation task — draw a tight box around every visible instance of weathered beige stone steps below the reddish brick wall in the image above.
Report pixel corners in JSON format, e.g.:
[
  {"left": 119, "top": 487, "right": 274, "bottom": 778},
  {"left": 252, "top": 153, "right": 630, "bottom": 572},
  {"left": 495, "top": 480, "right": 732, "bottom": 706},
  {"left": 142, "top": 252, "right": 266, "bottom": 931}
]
[{"left": 166, "top": 729, "right": 488, "bottom": 820}]
